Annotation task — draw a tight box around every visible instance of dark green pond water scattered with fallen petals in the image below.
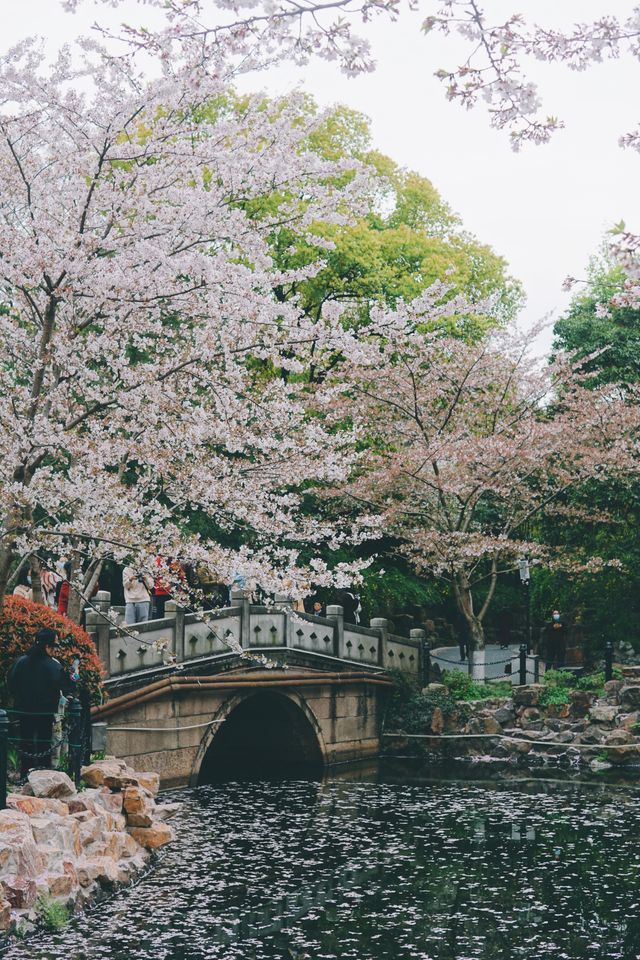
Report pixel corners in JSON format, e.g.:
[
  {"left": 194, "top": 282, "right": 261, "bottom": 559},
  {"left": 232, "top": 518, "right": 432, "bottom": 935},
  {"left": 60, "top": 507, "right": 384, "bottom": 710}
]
[{"left": 5, "top": 774, "right": 640, "bottom": 960}]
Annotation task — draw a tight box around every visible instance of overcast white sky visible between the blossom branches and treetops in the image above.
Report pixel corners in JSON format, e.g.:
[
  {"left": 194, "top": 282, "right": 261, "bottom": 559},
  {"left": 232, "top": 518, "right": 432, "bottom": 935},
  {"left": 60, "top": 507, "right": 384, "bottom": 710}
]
[{"left": 6, "top": 0, "right": 640, "bottom": 344}]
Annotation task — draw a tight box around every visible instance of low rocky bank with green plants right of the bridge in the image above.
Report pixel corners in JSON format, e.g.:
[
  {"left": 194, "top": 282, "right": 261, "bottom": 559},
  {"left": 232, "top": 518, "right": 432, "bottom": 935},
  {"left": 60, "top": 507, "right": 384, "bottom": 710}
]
[{"left": 418, "top": 680, "right": 640, "bottom": 770}]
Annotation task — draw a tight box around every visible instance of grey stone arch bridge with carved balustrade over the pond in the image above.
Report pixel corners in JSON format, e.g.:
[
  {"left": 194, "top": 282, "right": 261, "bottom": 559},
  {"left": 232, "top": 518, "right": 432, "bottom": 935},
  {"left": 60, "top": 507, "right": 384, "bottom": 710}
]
[{"left": 87, "top": 592, "right": 424, "bottom": 786}]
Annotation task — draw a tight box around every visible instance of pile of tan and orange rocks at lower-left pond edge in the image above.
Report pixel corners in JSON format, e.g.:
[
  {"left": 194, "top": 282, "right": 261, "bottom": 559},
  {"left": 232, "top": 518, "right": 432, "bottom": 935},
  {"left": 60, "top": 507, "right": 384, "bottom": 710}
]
[{"left": 0, "top": 757, "right": 177, "bottom": 933}]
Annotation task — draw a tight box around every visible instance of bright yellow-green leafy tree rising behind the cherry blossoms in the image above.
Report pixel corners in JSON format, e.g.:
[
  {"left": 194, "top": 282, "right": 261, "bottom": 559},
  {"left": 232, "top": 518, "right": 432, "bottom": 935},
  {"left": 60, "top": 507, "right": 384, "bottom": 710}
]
[{"left": 274, "top": 98, "right": 523, "bottom": 340}]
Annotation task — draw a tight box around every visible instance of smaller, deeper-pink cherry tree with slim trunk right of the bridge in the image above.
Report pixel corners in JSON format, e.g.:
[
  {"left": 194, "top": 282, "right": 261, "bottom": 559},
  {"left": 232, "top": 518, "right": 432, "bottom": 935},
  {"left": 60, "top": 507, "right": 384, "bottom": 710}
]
[{"left": 340, "top": 289, "right": 640, "bottom": 648}]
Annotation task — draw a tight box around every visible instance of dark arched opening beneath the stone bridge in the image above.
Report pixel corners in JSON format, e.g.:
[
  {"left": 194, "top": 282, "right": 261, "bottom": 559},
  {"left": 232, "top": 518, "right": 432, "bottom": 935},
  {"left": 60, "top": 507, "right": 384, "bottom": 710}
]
[{"left": 198, "top": 692, "right": 324, "bottom": 786}]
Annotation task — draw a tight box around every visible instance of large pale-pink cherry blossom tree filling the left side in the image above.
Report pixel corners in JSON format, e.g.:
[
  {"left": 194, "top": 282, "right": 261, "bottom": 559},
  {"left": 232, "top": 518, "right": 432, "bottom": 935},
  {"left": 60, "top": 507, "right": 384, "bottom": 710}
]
[{"left": 0, "top": 41, "right": 378, "bottom": 601}]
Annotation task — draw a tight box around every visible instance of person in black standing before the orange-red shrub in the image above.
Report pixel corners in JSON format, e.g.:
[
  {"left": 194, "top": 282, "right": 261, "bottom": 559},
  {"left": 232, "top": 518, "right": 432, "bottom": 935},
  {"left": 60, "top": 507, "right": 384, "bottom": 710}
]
[{"left": 8, "top": 627, "right": 75, "bottom": 778}]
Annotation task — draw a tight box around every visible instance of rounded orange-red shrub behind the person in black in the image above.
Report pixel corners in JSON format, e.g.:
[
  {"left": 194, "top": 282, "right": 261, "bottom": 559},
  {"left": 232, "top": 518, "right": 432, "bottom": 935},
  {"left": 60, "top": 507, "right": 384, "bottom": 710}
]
[{"left": 0, "top": 597, "right": 104, "bottom": 707}]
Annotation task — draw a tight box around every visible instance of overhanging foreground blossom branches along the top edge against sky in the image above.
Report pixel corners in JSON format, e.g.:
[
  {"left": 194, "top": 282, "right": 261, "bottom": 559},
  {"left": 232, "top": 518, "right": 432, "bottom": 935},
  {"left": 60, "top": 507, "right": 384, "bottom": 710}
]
[{"left": 62, "top": 0, "right": 640, "bottom": 309}]
